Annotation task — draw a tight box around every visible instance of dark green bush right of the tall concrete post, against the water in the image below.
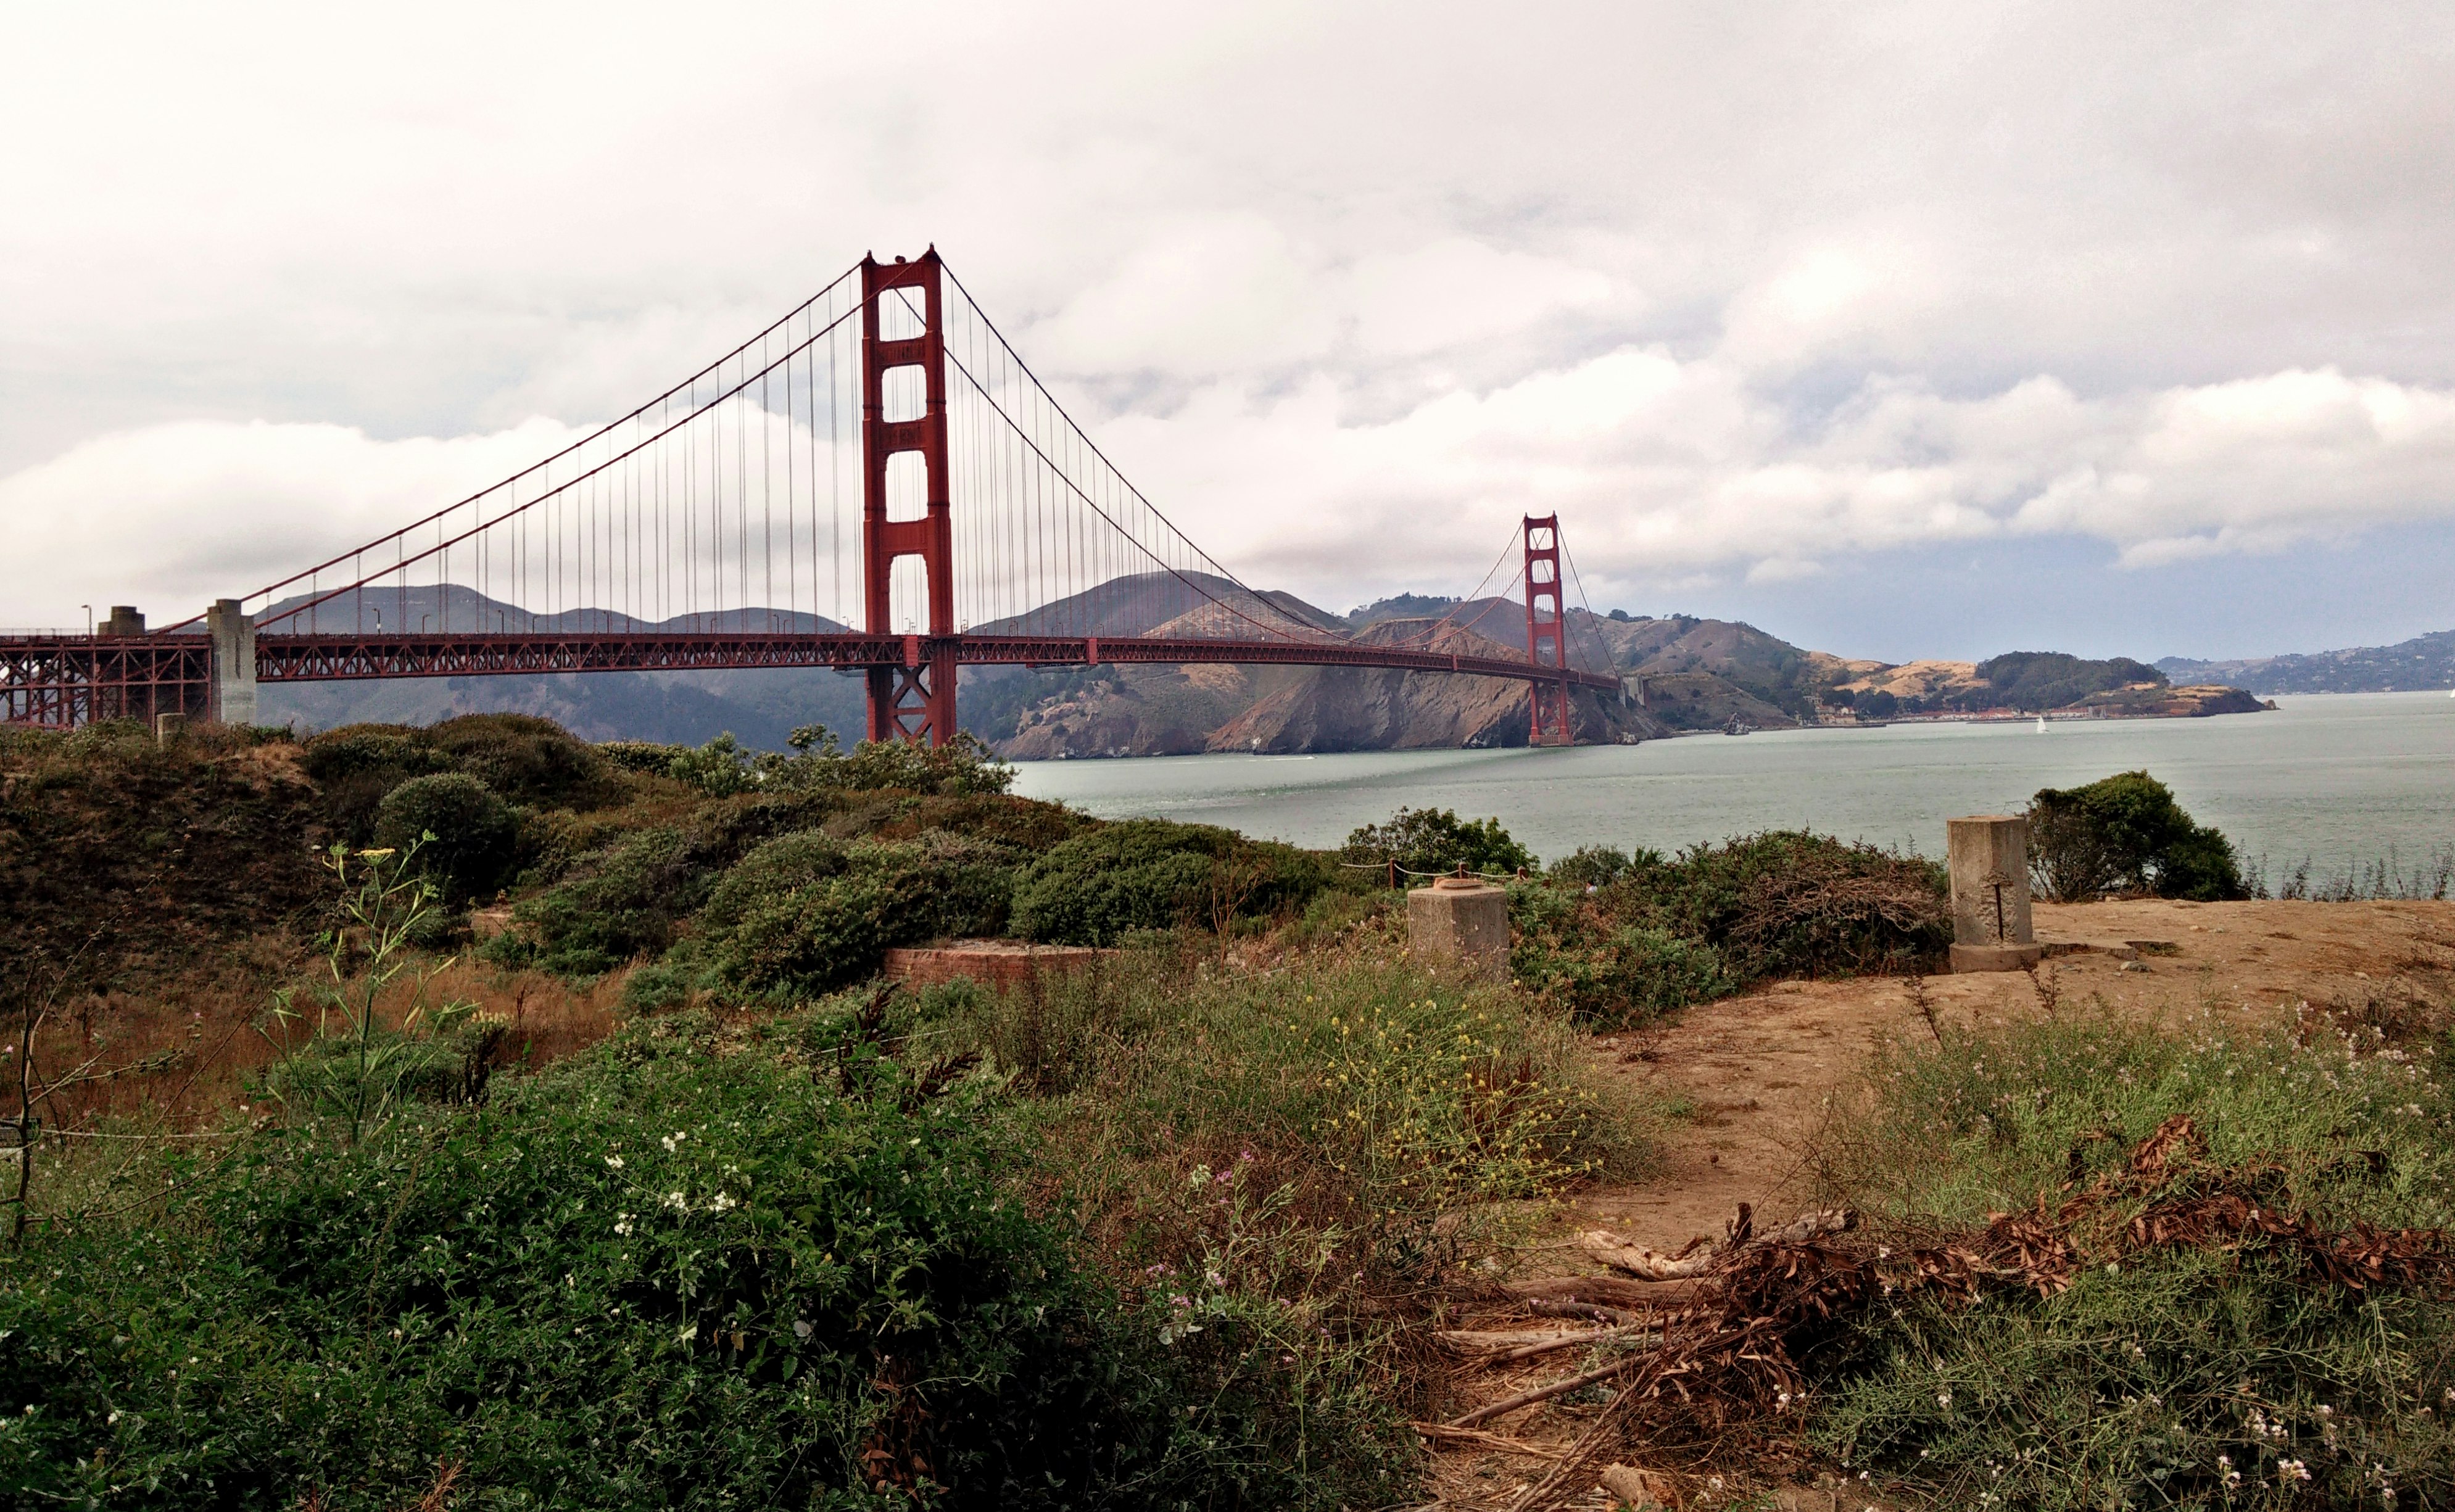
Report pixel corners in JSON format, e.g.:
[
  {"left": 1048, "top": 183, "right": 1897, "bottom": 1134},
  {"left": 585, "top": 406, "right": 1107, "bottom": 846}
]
[{"left": 2028, "top": 770, "right": 2249, "bottom": 903}]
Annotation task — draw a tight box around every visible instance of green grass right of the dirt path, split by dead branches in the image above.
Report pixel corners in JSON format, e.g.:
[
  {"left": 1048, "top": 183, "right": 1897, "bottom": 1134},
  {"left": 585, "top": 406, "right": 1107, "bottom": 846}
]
[{"left": 1812, "top": 1006, "right": 2455, "bottom": 1510}]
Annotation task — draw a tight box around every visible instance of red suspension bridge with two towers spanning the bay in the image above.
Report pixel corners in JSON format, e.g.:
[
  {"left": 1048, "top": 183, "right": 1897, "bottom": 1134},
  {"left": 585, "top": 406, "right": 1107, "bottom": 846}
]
[{"left": 0, "top": 250, "right": 1623, "bottom": 744}]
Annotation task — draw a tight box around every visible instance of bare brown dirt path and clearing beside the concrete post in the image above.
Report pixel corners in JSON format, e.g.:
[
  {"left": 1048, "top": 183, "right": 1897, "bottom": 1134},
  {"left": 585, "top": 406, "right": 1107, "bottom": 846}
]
[{"left": 1434, "top": 901, "right": 2455, "bottom": 1510}]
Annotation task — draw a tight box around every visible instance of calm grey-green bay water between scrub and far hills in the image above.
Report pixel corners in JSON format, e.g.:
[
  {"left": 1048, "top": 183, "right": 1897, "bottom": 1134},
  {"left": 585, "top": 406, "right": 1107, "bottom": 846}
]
[{"left": 1014, "top": 692, "right": 2455, "bottom": 878}]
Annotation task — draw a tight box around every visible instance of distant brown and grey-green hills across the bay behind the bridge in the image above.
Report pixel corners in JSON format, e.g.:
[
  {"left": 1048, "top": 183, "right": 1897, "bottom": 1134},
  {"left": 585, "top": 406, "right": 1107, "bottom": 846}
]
[{"left": 239, "top": 572, "right": 2248, "bottom": 758}]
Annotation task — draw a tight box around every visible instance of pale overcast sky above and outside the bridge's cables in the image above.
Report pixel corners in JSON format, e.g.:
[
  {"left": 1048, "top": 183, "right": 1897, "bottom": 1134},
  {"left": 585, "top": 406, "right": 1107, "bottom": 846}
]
[{"left": 0, "top": 0, "right": 2455, "bottom": 660}]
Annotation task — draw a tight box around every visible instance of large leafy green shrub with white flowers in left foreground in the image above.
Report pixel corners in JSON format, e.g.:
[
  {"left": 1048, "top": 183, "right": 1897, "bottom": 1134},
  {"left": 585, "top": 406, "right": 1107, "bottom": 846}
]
[{"left": 0, "top": 1021, "right": 1404, "bottom": 1512}]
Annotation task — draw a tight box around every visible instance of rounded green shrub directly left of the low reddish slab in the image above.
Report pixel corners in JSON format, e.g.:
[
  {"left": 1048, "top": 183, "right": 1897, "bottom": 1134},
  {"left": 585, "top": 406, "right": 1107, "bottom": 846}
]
[{"left": 695, "top": 835, "right": 1011, "bottom": 994}]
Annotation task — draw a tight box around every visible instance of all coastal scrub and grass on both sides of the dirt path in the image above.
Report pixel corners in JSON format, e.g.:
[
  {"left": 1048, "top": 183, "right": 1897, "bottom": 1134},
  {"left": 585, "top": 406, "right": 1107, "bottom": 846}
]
[{"left": 0, "top": 717, "right": 2416, "bottom": 1512}]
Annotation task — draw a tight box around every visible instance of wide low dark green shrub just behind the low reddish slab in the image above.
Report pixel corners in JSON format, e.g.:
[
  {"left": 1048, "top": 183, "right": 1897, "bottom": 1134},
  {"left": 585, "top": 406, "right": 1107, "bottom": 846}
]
[{"left": 1014, "top": 820, "right": 1331, "bottom": 945}]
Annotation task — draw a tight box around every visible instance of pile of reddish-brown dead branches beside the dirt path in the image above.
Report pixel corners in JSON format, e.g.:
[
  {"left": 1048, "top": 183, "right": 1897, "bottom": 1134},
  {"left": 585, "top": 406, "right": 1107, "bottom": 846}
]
[{"left": 1446, "top": 1117, "right": 2455, "bottom": 1512}]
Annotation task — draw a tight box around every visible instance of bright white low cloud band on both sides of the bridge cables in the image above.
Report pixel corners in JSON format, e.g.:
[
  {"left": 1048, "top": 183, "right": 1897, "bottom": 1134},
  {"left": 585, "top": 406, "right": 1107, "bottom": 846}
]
[{"left": 0, "top": 349, "right": 2455, "bottom": 621}]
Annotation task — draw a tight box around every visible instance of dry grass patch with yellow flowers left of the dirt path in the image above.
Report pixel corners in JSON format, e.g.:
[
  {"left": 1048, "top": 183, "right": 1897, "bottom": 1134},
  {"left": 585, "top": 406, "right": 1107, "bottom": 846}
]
[{"left": 918, "top": 918, "right": 1652, "bottom": 1421}]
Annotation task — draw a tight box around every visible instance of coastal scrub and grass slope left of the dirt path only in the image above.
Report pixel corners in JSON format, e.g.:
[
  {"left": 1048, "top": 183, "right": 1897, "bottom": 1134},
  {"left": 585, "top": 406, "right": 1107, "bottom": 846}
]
[{"left": 0, "top": 719, "right": 1647, "bottom": 1507}]
